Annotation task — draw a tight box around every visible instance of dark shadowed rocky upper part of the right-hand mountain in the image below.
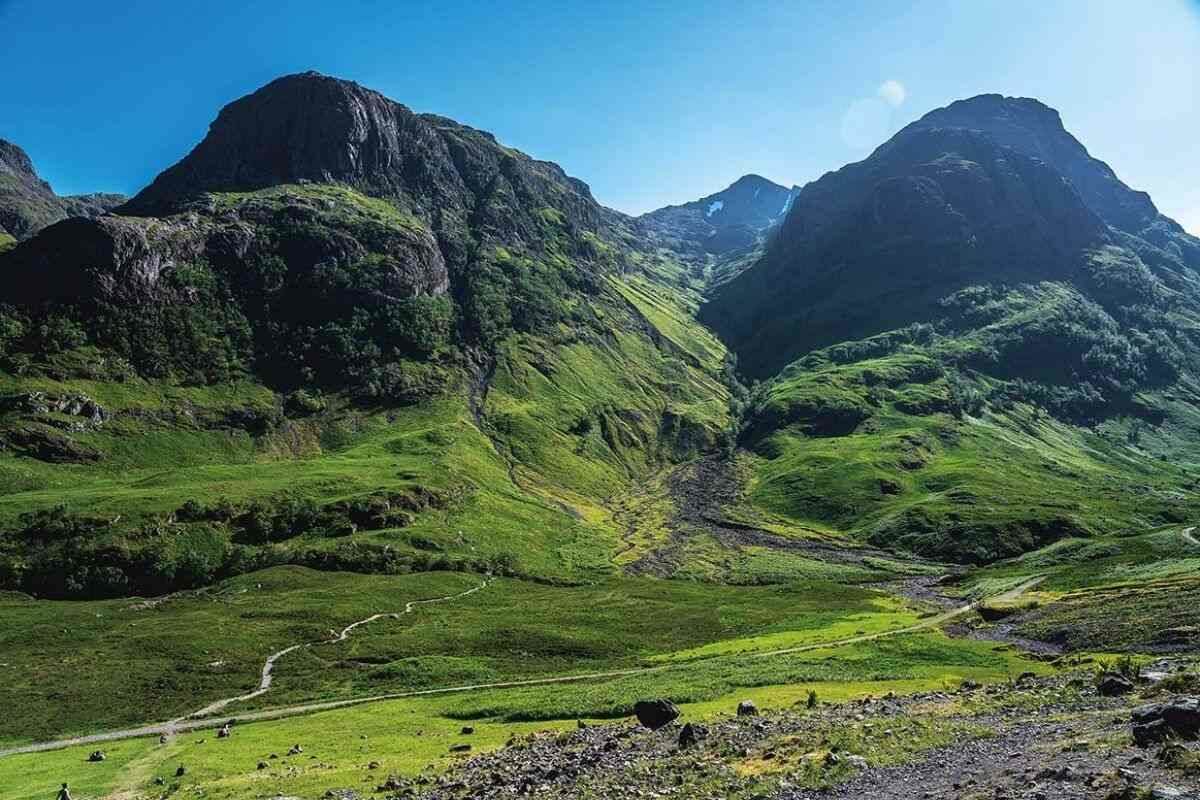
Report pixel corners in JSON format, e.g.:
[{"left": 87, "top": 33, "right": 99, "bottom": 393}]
[{"left": 702, "top": 95, "right": 1200, "bottom": 378}]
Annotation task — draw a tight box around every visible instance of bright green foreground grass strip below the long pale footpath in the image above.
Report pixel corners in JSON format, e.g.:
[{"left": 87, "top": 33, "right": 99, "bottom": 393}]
[{"left": 0, "top": 633, "right": 1045, "bottom": 800}]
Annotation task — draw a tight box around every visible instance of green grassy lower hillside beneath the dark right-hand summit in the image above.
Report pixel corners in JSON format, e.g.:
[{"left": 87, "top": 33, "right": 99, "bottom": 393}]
[{"left": 743, "top": 278, "right": 1200, "bottom": 563}]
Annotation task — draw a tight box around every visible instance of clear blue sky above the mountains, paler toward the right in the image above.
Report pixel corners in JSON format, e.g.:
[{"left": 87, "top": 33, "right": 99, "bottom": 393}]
[{"left": 0, "top": 0, "right": 1200, "bottom": 234}]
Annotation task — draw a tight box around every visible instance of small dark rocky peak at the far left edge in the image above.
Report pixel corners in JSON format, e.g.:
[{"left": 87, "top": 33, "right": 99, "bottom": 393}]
[{"left": 0, "top": 139, "right": 125, "bottom": 246}]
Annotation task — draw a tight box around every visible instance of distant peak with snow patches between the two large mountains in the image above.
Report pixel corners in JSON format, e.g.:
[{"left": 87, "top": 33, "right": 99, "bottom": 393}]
[{"left": 638, "top": 175, "right": 794, "bottom": 254}]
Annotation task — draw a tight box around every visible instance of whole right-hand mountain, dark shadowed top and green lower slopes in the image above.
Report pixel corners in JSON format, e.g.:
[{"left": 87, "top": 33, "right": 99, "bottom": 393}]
[{"left": 700, "top": 95, "right": 1200, "bottom": 563}]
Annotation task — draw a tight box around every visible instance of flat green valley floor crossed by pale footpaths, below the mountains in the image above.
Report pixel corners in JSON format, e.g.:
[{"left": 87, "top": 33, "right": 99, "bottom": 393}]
[{"left": 0, "top": 459, "right": 1200, "bottom": 800}]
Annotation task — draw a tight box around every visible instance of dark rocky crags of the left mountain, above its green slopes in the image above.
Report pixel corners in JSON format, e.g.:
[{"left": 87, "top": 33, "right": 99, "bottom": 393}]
[{"left": 0, "top": 73, "right": 634, "bottom": 396}]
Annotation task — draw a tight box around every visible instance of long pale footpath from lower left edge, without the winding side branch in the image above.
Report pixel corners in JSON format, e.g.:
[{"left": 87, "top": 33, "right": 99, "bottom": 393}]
[{"left": 0, "top": 576, "right": 1045, "bottom": 758}]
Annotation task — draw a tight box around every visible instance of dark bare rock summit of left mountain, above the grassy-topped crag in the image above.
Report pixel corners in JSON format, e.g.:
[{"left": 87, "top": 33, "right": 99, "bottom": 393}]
[{"left": 120, "top": 72, "right": 614, "bottom": 267}]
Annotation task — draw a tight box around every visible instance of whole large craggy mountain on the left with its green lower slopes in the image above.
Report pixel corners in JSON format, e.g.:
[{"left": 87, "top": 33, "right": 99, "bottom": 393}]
[{"left": 0, "top": 72, "right": 728, "bottom": 596}]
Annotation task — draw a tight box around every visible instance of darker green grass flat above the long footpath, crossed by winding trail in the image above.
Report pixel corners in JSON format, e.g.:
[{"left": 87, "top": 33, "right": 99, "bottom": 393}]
[{"left": 0, "top": 567, "right": 912, "bottom": 741}]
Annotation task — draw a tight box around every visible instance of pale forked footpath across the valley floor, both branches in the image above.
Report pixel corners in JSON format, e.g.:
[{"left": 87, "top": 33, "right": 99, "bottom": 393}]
[{"left": 0, "top": 576, "right": 1045, "bottom": 758}]
